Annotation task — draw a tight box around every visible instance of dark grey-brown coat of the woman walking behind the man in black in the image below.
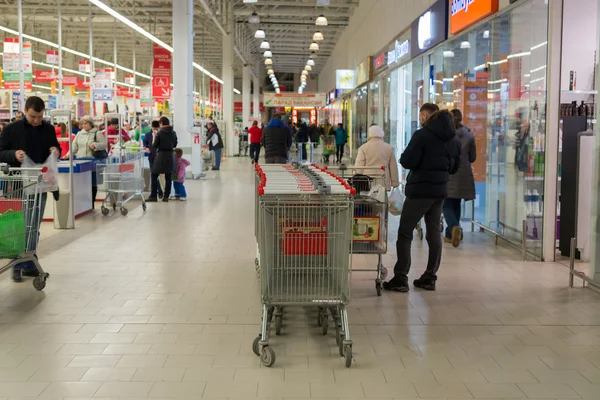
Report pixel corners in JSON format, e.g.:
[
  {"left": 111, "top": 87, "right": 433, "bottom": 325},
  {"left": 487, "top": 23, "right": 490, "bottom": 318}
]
[{"left": 448, "top": 126, "right": 477, "bottom": 200}]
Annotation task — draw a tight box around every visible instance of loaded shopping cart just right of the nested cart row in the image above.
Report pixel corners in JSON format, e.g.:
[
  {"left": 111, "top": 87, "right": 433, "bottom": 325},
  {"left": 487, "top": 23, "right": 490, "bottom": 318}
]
[{"left": 329, "top": 164, "right": 389, "bottom": 296}]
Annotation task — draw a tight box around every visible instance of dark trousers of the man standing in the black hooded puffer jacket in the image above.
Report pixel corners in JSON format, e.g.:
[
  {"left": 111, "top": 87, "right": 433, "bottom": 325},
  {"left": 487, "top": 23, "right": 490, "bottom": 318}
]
[{"left": 394, "top": 198, "right": 444, "bottom": 282}]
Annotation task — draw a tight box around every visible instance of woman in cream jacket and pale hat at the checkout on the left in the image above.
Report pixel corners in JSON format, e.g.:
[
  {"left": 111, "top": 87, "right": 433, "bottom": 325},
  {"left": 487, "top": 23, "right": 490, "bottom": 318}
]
[{"left": 65, "top": 115, "right": 108, "bottom": 208}]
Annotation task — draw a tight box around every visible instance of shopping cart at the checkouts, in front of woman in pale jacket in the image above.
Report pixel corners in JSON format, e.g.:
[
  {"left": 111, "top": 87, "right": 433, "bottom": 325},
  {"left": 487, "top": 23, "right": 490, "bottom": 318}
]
[{"left": 96, "top": 148, "right": 146, "bottom": 216}]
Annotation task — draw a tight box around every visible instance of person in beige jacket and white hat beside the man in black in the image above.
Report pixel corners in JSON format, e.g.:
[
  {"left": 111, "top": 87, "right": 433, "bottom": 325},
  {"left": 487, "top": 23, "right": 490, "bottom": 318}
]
[{"left": 354, "top": 125, "right": 400, "bottom": 190}]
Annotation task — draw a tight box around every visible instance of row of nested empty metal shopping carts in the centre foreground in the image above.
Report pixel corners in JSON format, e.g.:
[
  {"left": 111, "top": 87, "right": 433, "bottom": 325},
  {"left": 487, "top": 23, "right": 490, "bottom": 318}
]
[{"left": 252, "top": 165, "right": 354, "bottom": 367}]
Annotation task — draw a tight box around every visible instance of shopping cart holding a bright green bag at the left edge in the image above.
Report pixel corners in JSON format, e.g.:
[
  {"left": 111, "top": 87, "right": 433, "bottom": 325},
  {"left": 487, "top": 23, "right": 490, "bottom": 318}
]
[{"left": 0, "top": 164, "right": 50, "bottom": 290}]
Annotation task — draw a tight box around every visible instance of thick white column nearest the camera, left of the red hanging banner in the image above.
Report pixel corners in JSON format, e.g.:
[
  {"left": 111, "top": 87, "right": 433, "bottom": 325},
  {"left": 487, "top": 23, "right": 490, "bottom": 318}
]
[{"left": 172, "top": 0, "right": 194, "bottom": 147}]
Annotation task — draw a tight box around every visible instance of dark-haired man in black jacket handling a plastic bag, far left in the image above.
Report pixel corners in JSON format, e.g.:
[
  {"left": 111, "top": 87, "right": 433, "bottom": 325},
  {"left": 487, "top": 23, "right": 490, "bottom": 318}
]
[{"left": 0, "top": 96, "right": 60, "bottom": 282}]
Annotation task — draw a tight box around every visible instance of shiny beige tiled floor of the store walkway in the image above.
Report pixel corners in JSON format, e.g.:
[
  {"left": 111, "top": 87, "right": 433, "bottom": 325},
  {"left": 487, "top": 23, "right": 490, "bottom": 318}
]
[{"left": 0, "top": 160, "right": 600, "bottom": 400}]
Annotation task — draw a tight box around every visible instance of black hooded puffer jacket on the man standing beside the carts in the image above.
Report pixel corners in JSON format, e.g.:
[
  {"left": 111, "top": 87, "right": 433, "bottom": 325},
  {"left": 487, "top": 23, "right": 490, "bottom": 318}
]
[{"left": 400, "top": 110, "right": 461, "bottom": 199}]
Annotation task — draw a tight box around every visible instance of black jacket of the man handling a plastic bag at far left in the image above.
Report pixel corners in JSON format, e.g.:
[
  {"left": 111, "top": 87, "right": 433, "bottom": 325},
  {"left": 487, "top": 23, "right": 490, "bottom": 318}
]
[{"left": 0, "top": 118, "right": 60, "bottom": 167}]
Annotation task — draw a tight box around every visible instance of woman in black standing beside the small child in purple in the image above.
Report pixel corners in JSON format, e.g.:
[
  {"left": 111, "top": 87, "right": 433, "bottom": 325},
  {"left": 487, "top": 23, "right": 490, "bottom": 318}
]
[{"left": 146, "top": 117, "right": 177, "bottom": 203}]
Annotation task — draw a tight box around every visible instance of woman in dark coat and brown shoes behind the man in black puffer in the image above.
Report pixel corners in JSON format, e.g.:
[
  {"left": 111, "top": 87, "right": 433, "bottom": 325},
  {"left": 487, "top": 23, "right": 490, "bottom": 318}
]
[{"left": 444, "top": 109, "right": 477, "bottom": 247}]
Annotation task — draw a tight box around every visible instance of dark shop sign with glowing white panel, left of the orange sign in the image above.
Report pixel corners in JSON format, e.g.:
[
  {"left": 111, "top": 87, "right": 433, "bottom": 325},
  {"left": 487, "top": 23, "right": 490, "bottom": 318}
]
[{"left": 411, "top": 0, "right": 448, "bottom": 58}]
